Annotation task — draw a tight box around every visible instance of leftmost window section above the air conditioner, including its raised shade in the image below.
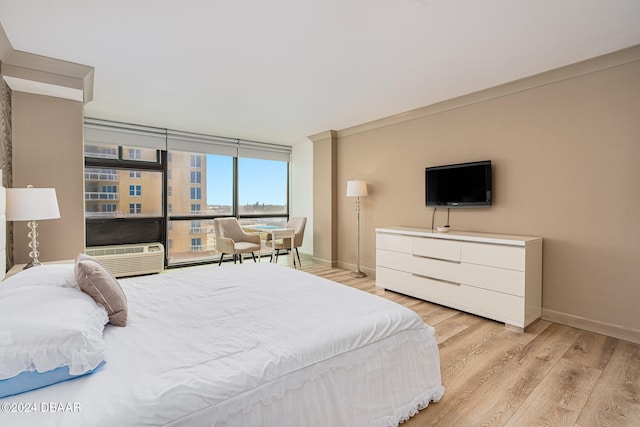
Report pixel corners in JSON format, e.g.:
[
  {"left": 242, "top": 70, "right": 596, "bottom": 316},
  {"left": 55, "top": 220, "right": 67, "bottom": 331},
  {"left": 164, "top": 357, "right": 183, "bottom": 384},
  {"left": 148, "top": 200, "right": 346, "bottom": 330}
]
[{"left": 84, "top": 119, "right": 166, "bottom": 247}]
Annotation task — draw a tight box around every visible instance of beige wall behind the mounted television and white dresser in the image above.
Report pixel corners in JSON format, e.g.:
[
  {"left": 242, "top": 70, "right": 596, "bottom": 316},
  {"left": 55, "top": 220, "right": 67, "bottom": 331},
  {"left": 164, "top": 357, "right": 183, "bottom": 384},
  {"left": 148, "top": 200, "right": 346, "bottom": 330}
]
[{"left": 322, "top": 47, "right": 640, "bottom": 342}]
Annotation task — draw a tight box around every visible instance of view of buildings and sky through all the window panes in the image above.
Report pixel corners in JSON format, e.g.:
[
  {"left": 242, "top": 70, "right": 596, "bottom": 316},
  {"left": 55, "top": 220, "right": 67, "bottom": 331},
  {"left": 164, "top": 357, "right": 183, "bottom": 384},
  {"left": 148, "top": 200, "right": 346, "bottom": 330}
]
[{"left": 85, "top": 144, "right": 288, "bottom": 264}]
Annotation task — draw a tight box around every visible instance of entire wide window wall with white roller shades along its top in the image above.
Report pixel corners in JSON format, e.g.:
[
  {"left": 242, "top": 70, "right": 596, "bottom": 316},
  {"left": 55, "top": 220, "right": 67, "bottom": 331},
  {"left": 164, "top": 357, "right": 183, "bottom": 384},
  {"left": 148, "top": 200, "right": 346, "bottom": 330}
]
[{"left": 84, "top": 119, "right": 290, "bottom": 264}]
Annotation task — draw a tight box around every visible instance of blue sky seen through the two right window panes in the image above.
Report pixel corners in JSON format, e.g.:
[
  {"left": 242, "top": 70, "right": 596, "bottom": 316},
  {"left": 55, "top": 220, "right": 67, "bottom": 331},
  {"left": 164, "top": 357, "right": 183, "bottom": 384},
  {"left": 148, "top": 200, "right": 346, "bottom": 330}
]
[{"left": 206, "top": 154, "right": 287, "bottom": 206}]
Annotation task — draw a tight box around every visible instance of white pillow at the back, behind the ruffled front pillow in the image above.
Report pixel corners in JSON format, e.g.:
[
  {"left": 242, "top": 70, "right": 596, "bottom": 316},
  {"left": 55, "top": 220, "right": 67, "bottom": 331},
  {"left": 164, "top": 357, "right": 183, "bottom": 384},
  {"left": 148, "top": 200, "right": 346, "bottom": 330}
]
[{"left": 0, "top": 264, "right": 78, "bottom": 292}]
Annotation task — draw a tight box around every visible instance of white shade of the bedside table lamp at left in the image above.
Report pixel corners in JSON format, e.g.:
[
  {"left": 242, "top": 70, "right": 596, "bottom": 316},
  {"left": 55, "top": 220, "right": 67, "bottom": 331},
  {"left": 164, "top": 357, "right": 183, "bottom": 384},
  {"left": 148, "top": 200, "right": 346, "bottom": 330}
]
[{"left": 7, "top": 188, "right": 60, "bottom": 221}]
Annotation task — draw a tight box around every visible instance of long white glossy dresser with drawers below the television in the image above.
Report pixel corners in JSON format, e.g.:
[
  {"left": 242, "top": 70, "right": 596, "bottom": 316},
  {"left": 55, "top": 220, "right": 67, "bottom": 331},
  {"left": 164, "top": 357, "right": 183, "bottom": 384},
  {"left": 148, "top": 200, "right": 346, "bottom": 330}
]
[{"left": 376, "top": 227, "right": 542, "bottom": 330}]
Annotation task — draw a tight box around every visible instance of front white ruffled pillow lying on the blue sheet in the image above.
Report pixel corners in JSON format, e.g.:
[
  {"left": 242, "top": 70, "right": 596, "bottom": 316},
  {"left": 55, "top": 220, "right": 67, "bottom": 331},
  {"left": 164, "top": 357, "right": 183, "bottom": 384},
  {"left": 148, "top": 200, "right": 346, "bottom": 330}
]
[{"left": 0, "top": 284, "right": 109, "bottom": 380}]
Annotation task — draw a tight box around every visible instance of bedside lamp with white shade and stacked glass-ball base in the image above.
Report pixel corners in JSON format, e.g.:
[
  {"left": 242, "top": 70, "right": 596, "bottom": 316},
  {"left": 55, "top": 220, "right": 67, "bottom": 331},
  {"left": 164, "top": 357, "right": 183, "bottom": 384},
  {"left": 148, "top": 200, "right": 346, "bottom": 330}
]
[{"left": 7, "top": 186, "right": 60, "bottom": 269}]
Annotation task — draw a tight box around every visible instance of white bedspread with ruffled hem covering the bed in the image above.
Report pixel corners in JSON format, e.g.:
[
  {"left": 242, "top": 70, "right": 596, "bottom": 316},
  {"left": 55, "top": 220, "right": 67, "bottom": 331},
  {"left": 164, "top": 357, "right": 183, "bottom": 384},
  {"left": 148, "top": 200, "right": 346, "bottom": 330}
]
[{"left": 0, "top": 263, "right": 444, "bottom": 427}]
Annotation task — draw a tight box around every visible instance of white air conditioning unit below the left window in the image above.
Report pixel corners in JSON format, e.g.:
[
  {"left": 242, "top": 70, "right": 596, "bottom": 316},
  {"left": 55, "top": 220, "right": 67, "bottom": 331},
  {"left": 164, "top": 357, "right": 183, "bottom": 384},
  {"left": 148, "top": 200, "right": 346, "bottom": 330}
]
[{"left": 86, "top": 243, "right": 164, "bottom": 277}]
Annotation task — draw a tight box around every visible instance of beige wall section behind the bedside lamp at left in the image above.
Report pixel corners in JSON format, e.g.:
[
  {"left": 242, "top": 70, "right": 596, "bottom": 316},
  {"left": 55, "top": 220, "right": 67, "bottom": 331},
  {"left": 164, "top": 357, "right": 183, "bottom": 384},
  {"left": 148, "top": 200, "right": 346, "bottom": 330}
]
[{"left": 11, "top": 91, "right": 84, "bottom": 264}]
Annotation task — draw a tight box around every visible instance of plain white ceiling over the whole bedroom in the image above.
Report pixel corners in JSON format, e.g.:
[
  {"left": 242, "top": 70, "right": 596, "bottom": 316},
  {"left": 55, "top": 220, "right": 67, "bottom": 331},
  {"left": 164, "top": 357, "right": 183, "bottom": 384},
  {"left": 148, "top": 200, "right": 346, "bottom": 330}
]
[{"left": 0, "top": 0, "right": 640, "bottom": 144}]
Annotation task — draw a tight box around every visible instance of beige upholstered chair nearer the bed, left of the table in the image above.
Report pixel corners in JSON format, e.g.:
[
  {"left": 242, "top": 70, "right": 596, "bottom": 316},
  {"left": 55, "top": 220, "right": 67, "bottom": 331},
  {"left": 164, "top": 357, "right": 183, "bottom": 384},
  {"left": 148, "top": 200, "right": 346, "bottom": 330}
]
[{"left": 213, "top": 218, "right": 261, "bottom": 265}]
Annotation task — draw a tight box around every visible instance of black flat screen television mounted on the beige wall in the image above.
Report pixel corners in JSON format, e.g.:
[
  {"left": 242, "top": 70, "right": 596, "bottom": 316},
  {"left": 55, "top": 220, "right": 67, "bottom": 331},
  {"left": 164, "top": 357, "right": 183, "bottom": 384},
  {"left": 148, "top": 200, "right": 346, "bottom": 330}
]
[{"left": 425, "top": 160, "right": 491, "bottom": 208}]
